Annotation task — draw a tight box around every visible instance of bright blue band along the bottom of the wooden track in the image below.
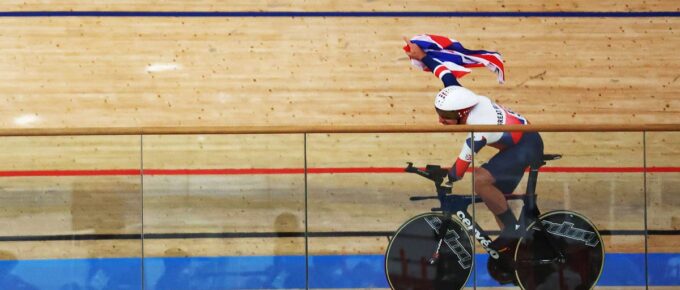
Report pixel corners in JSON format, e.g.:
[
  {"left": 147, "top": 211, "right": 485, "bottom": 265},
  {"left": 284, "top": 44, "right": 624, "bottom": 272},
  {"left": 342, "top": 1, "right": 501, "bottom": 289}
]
[{"left": 0, "top": 253, "right": 680, "bottom": 290}]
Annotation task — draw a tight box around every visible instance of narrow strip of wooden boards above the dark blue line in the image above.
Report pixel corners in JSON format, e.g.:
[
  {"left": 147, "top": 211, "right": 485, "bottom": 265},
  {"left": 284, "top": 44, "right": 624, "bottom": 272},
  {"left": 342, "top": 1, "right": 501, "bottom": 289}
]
[{"left": 0, "top": 0, "right": 680, "bottom": 12}]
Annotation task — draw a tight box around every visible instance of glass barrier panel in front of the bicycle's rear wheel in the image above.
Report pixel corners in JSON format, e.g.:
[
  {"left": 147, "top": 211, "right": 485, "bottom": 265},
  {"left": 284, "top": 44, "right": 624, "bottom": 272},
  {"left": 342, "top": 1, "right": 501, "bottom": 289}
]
[{"left": 475, "top": 132, "right": 645, "bottom": 289}]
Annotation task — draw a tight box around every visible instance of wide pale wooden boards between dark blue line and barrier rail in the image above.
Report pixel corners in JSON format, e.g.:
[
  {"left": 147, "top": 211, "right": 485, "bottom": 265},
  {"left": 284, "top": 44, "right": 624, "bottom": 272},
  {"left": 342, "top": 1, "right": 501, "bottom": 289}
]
[{"left": 0, "top": 17, "right": 680, "bottom": 129}]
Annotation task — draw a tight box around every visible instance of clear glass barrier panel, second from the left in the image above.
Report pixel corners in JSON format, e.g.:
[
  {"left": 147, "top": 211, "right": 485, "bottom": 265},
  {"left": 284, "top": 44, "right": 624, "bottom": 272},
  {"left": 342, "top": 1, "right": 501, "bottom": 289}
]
[{"left": 143, "top": 134, "right": 306, "bottom": 290}]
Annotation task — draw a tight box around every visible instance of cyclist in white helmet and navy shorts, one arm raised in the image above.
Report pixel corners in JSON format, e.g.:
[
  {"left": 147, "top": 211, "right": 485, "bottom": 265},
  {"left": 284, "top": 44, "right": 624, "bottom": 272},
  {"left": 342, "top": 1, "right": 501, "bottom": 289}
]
[{"left": 404, "top": 38, "right": 543, "bottom": 280}]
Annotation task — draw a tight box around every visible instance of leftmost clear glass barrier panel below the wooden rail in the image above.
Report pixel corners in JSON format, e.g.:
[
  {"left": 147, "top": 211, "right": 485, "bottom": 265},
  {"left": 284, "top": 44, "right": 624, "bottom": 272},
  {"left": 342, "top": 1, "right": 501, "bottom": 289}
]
[{"left": 0, "top": 136, "right": 142, "bottom": 290}]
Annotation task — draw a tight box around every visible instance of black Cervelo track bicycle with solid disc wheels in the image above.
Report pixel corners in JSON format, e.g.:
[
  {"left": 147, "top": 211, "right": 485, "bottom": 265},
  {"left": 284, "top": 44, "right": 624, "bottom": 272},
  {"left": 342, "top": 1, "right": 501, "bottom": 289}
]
[{"left": 385, "top": 154, "right": 604, "bottom": 290}]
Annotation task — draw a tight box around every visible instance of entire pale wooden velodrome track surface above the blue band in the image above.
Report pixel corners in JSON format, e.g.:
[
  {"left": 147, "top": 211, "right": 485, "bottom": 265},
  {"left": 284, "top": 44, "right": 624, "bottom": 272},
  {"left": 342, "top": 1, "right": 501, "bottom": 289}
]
[{"left": 0, "top": 0, "right": 680, "bottom": 288}]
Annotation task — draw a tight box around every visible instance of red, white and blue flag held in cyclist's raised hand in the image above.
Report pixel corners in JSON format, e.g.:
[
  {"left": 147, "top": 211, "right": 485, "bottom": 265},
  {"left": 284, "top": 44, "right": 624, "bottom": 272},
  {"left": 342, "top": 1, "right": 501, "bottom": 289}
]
[{"left": 404, "top": 34, "right": 505, "bottom": 84}]
